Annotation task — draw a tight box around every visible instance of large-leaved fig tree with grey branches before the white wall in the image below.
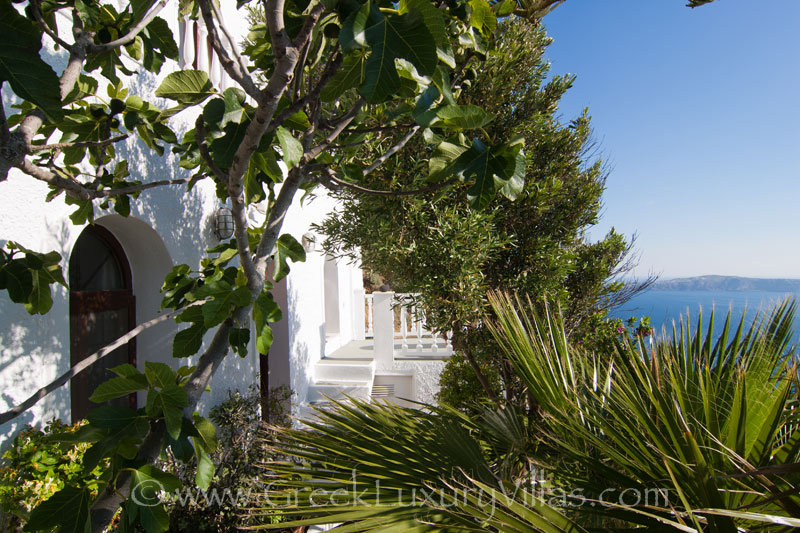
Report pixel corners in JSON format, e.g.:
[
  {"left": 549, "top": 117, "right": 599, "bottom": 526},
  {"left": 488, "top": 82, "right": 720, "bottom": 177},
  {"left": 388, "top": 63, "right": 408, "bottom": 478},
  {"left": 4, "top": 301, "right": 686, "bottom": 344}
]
[{"left": 0, "top": 0, "right": 564, "bottom": 531}]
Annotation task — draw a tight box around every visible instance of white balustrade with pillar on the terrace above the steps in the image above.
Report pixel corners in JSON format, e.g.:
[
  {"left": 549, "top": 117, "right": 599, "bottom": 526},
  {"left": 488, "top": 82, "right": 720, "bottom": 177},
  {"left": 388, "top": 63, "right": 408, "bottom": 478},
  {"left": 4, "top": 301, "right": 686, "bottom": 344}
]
[{"left": 364, "top": 292, "right": 453, "bottom": 366}]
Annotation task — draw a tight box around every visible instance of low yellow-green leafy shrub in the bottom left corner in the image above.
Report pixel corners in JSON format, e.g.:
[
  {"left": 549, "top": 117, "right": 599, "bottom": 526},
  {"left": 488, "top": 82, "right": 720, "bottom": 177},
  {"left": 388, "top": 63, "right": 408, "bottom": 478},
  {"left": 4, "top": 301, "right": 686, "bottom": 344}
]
[{"left": 0, "top": 419, "right": 108, "bottom": 531}]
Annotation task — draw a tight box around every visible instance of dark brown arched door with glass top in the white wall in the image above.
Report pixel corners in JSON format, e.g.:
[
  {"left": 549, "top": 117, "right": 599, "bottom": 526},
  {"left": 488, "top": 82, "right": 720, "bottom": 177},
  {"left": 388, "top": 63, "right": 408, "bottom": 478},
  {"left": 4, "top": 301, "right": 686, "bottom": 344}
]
[{"left": 69, "top": 224, "right": 136, "bottom": 422}]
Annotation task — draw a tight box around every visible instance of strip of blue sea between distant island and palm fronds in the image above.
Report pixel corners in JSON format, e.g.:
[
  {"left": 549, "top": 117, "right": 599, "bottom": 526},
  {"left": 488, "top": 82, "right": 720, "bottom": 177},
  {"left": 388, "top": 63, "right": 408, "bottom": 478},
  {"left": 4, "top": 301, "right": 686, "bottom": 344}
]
[{"left": 611, "top": 290, "right": 800, "bottom": 344}]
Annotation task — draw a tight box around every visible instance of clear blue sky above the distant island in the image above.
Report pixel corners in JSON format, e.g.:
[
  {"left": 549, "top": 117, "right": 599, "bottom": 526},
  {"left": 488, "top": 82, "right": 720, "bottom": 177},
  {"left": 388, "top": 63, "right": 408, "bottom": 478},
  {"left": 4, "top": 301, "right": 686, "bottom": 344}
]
[{"left": 545, "top": 0, "right": 800, "bottom": 278}]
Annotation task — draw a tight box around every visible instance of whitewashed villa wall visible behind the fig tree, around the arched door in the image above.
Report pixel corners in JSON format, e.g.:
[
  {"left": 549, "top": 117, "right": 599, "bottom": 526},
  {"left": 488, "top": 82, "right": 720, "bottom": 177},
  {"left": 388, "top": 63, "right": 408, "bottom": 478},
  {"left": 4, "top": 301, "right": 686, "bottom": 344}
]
[{"left": 0, "top": 2, "right": 368, "bottom": 445}]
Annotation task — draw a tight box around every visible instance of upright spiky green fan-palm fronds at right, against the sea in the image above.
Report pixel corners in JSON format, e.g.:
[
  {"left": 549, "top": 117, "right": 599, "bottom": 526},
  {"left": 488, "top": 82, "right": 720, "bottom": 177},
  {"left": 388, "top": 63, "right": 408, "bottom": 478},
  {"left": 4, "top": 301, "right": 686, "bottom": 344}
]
[{"left": 489, "top": 294, "right": 800, "bottom": 531}]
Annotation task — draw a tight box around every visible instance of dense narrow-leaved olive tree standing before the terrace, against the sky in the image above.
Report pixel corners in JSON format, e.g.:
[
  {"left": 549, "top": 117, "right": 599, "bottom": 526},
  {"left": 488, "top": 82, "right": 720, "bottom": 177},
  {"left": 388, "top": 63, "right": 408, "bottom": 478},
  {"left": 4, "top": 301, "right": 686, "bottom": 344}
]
[{"left": 321, "top": 19, "right": 641, "bottom": 407}]
